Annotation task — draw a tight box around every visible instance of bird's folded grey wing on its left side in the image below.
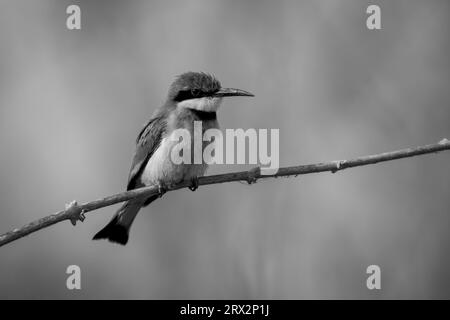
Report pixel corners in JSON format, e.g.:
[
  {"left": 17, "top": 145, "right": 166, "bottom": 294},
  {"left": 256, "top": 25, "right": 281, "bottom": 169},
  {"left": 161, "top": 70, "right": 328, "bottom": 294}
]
[{"left": 127, "top": 116, "right": 166, "bottom": 190}]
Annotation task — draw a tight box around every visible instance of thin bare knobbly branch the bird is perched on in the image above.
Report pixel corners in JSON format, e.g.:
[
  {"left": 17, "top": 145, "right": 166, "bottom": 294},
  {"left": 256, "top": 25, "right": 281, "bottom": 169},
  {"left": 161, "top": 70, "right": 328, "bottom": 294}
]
[{"left": 0, "top": 139, "right": 450, "bottom": 247}]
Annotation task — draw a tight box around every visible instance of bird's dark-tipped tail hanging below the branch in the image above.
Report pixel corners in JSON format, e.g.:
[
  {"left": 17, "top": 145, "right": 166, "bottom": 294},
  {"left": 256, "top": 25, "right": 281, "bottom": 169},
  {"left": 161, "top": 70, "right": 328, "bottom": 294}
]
[{"left": 92, "top": 199, "right": 145, "bottom": 245}]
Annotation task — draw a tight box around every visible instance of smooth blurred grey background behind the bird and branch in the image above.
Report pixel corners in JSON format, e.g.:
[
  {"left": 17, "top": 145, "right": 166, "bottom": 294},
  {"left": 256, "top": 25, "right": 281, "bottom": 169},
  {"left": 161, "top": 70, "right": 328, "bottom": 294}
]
[{"left": 0, "top": 0, "right": 450, "bottom": 299}]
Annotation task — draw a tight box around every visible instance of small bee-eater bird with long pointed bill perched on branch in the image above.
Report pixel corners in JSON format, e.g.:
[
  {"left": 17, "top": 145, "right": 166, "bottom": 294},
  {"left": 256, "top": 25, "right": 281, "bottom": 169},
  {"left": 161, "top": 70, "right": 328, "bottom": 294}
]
[{"left": 93, "top": 72, "right": 253, "bottom": 245}]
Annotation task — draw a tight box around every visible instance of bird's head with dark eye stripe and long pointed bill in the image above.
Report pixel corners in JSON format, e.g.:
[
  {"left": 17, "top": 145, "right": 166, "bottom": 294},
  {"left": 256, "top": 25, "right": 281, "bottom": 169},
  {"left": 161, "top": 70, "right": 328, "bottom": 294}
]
[{"left": 168, "top": 72, "right": 253, "bottom": 112}]
